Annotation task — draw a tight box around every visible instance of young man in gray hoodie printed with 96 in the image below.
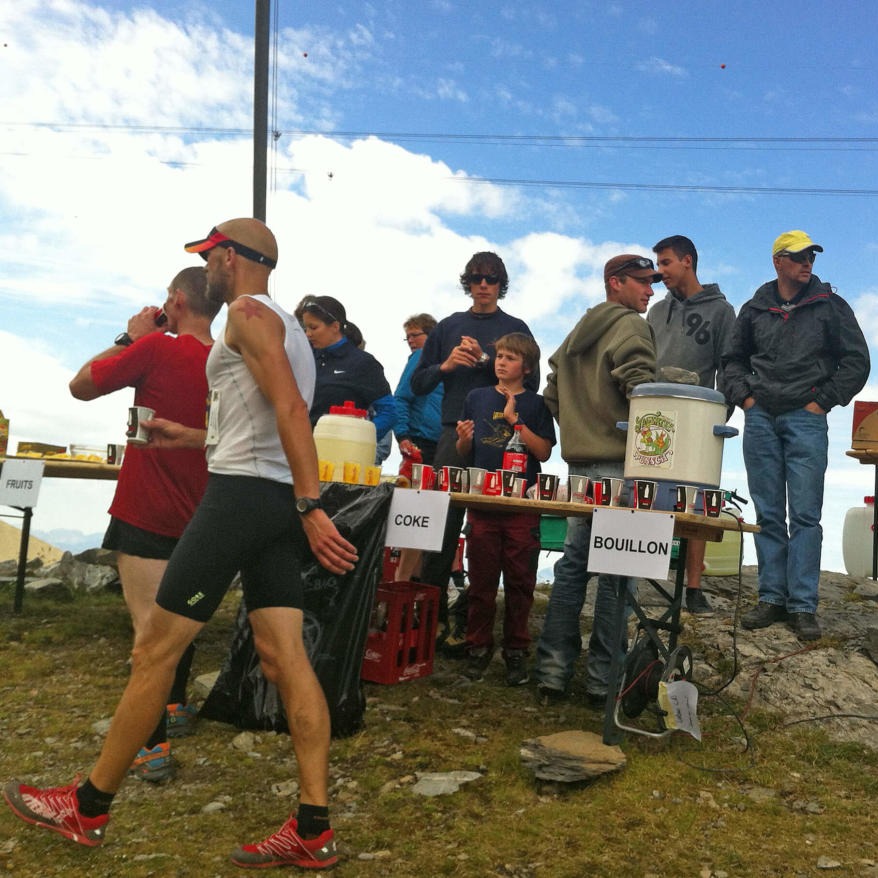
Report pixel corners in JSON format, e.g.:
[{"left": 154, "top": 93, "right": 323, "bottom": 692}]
[{"left": 646, "top": 235, "right": 735, "bottom": 614}]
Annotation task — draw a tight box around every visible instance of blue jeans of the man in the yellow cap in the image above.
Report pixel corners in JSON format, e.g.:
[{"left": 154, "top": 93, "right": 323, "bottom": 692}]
[{"left": 743, "top": 405, "right": 828, "bottom": 613}]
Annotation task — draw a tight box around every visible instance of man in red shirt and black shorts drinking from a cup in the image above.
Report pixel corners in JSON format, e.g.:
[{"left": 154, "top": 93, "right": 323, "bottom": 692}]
[{"left": 70, "top": 268, "right": 221, "bottom": 782}]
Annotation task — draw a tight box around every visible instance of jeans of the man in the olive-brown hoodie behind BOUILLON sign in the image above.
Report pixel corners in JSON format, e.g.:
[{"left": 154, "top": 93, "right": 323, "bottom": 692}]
[{"left": 534, "top": 462, "right": 635, "bottom": 695}]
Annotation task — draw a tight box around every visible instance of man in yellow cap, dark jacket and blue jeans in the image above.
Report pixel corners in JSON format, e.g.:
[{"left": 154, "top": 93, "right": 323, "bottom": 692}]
[{"left": 723, "top": 230, "right": 869, "bottom": 640}]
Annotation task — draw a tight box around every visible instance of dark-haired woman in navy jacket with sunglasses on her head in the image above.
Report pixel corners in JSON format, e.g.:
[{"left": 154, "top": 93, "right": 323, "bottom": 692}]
[{"left": 296, "top": 296, "right": 396, "bottom": 442}]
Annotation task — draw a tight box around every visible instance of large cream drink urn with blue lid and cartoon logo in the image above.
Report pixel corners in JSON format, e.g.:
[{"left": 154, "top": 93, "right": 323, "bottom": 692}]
[{"left": 619, "top": 384, "right": 738, "bottom": 488}]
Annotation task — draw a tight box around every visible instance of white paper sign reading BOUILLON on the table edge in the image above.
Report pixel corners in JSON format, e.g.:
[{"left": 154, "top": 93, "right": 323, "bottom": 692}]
[{"left": 588, "top": 507, "right": 674, "bottom": 579}]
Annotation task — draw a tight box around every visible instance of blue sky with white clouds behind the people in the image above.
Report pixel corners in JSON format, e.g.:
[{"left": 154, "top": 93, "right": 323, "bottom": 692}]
[{"left": 0, "top": 0, "right": 878, "bottom": 569}]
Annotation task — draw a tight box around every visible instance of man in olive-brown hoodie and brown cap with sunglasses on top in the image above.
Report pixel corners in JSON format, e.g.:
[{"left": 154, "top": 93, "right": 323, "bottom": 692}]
[{"left": 534, "top": 253, "right": 661, "bottom": 704}]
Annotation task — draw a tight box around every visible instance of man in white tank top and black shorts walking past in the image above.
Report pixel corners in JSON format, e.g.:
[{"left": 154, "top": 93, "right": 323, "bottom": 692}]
[{"left": 4, "top": 218, "right": 357, "bottom": 868}]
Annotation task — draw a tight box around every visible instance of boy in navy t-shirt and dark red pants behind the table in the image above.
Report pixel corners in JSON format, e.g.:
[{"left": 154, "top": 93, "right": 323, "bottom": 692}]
[{"left": 457, "top": 332, "right": 555, "bottom": 686}]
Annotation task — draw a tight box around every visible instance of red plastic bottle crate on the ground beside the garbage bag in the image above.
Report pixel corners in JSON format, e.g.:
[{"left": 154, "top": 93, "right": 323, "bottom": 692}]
[{"left": 361, "top": 582, "right": 439, "bottom": 683}]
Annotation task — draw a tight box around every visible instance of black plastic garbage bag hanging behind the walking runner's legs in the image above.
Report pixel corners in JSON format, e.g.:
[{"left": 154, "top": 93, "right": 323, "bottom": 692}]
[{"left": 199, "top": 482, "right": 393, "bottom": 737}]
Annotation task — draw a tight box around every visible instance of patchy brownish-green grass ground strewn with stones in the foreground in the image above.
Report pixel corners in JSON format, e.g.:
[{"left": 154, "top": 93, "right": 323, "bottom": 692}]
[{"left": 0, "top": 589, "right": 878, "bottom": 878}]
